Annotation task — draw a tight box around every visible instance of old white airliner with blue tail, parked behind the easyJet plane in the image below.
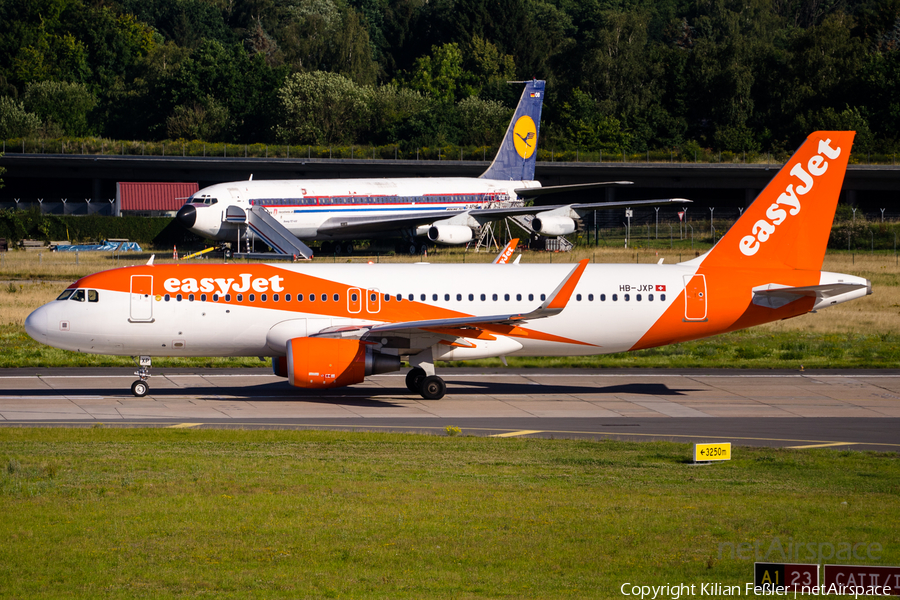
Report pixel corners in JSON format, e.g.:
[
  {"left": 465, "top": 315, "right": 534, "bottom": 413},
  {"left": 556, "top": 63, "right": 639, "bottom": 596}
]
[{"left": 176, "top": 80, "right": 684, "bottom": 253}]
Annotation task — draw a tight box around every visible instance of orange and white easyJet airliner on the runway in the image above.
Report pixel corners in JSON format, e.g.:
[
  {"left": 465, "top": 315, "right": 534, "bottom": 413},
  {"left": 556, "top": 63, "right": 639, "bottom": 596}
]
[{"left": 25, "top": 131, "right": 872, "bottom": 399}]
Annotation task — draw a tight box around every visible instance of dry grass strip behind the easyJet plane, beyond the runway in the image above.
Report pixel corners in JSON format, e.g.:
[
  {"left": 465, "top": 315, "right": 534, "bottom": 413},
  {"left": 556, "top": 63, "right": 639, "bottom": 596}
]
[{"left": 0, "top": 248, "right": 900, "bottom": 369}]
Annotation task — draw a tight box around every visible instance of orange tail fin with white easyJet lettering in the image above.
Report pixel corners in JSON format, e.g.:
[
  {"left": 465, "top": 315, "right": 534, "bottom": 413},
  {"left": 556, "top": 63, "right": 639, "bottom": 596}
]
[{"left": 690, "top": 131, "right": 856, "bottom": 271}]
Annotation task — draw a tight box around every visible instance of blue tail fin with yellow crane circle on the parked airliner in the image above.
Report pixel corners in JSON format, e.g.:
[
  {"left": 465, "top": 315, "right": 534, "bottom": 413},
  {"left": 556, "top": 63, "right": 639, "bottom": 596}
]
[{"left": 481, "top": 79, "right": 546, "bottom": 181}]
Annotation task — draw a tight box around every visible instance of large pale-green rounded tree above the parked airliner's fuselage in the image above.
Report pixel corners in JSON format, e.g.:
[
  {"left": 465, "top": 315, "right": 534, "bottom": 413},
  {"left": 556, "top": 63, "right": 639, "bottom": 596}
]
[{"left": 277, "top": 71, "right": 371, "bottom": 144}]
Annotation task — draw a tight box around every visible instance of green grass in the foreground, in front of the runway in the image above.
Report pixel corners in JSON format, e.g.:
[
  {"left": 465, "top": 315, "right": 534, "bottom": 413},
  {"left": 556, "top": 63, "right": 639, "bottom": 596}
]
[{"left": 0, "top": 428, "right": 900, "bottom": 598}]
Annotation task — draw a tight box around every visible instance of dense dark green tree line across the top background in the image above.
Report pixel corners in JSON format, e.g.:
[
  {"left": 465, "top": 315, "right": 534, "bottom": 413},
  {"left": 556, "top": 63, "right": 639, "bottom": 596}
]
[{"left": 0, "top": 0, "right": 900, "bottom": 152}]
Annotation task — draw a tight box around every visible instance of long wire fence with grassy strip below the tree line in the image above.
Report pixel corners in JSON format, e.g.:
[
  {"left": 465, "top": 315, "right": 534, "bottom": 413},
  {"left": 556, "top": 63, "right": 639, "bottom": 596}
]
[{"left": 0, "top": 138, "right": 900, "bottom": 166}]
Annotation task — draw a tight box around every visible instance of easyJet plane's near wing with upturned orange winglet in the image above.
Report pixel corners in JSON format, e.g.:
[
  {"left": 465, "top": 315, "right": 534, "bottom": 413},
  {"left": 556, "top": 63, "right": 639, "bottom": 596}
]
[{"left": 310, "top": 259, "right": 588, "bottom": 339}]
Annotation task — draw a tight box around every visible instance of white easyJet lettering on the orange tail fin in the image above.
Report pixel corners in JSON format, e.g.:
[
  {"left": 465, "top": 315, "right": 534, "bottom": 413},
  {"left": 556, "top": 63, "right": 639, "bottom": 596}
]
[{"left": 740, "top": 139, "right": 841, "bottom": 256}]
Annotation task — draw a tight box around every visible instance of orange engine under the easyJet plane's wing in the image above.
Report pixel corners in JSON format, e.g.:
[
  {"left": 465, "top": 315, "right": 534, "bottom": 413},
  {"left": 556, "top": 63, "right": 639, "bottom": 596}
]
[{"left": 288, "top": 338, "right": 400, "bottom": 388}]
